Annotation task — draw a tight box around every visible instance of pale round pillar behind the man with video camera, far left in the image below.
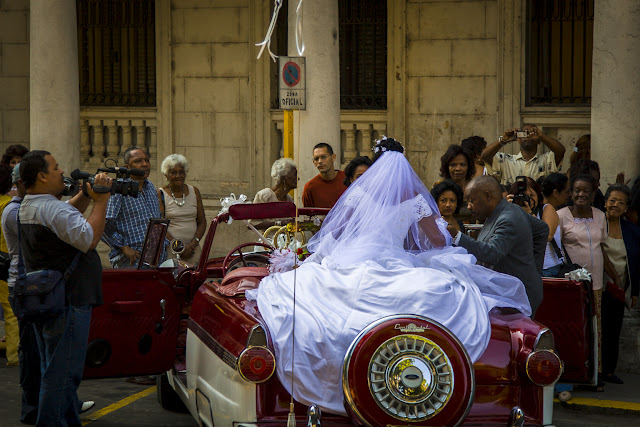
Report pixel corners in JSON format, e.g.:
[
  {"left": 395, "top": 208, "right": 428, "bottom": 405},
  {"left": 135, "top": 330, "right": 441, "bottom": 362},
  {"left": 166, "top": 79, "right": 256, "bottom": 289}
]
[{"left": 29, "top": 0, "right": 81, "bottom": 173}]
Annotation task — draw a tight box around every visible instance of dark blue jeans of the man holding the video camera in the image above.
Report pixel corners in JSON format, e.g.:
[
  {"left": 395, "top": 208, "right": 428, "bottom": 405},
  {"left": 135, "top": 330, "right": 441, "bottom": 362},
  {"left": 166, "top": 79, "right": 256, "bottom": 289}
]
[{"left": 34, "top": 305, "right": 91, "bottom": 427}]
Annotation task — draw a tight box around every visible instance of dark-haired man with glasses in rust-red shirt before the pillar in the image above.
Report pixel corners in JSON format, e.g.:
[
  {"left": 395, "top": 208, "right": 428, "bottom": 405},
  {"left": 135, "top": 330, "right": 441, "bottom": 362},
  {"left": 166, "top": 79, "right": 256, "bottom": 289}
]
[{"left": 302, "top": 142, "right": 347, "bottom": 208}]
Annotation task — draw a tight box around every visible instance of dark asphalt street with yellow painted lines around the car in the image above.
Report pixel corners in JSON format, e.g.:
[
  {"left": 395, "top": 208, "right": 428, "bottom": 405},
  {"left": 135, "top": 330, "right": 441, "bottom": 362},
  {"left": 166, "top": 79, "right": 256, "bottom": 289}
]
[{"left": 0, "top": 322, "right": 640, "bottom": 427}]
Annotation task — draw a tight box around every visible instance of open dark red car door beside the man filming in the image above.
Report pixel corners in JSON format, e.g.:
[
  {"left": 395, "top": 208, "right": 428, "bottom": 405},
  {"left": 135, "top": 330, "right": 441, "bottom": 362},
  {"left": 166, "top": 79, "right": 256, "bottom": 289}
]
[{"left": 84, "top": 219, "right": 181, "bottom": 378}]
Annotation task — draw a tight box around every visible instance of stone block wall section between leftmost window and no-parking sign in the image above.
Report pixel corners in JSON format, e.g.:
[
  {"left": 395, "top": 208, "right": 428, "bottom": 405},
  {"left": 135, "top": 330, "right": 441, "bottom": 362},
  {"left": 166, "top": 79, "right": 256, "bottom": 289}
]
[{"left": 171, "top": 0, "right": 264, "bottom": 200}]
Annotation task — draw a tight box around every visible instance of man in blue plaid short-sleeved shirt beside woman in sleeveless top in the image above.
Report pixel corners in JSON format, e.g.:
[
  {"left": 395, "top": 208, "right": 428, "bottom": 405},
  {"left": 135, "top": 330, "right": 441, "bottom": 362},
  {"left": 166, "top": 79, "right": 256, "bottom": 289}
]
[{"left": 102, "top": 147, "right": 165, "bottom": 268}]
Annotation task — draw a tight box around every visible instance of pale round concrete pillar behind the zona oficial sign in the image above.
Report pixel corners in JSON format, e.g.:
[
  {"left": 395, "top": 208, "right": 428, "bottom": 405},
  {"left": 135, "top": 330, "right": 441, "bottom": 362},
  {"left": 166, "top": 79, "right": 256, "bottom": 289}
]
[{"left": 289, "top": 0, "right": 341, "bottom": 192}]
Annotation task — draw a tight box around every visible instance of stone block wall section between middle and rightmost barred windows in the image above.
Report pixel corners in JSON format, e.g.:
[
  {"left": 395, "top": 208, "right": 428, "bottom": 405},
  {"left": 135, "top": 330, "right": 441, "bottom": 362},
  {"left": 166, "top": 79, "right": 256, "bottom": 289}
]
[{"left": 406, "top": 1, "right": 498, "bottom": 186}]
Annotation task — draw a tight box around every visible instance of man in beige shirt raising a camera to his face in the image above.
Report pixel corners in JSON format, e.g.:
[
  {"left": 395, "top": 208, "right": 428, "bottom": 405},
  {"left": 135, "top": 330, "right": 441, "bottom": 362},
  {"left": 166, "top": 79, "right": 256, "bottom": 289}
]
[{"left": 480, "top": 124, "right": 566, "bottom": 185}]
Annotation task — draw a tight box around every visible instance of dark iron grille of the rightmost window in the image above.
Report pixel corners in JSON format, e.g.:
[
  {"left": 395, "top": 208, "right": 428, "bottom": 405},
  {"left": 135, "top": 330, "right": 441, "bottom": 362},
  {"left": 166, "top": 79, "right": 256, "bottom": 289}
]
[{"left": 527, "top": 0, "right": 594, "bottom": 106}]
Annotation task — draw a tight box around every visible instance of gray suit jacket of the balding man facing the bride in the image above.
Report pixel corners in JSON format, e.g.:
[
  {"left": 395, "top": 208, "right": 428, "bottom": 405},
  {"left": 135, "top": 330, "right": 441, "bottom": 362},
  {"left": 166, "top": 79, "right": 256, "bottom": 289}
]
[{"left": 458, "top": 199, "right": 549, "bottom": 317}]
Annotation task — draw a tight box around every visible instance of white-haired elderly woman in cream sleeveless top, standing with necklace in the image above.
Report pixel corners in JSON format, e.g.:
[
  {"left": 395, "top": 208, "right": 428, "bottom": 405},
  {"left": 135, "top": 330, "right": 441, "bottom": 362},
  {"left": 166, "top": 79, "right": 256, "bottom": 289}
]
[{"left": 158, "top": 154, "right": 207, "bottom": 266}]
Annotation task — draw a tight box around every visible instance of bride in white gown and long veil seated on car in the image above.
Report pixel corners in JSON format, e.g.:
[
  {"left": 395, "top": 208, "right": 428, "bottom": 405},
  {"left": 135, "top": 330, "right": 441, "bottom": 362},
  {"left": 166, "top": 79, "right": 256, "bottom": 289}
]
[{"left": 247, "top": 138, "right": 531, "bottom": 415}]
